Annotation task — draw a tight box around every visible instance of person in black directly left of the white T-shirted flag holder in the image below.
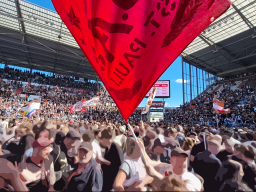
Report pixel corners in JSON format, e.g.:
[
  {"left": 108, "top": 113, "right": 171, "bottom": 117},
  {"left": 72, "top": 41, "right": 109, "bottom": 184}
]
[{"left": 99, "top": 129, "right": 124, "bottom": 191}]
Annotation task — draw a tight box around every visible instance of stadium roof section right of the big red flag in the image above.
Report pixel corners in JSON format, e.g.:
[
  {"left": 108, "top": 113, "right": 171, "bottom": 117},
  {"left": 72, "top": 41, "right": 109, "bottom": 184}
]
[{"left": 182, "top": 0, "right": 256, "bottom": 77}]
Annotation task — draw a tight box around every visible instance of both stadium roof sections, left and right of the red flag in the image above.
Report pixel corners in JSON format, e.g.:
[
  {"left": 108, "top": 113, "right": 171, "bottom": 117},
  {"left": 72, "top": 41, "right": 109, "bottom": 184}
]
[{"left": 0, "top": 0, "right": 256, "bottom": 79}]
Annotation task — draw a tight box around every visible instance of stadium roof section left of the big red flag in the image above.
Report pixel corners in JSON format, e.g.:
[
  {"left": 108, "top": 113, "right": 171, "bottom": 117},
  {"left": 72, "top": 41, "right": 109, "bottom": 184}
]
[{"left": 0, "top": 0, "right": 97, "bottom": 79}]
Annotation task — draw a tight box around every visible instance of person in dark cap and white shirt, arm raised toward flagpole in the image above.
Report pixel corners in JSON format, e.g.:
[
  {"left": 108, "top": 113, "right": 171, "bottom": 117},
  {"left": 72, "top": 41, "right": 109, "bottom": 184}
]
[{"left": 135, "top": 140, "right": 203, "bottom": 191}]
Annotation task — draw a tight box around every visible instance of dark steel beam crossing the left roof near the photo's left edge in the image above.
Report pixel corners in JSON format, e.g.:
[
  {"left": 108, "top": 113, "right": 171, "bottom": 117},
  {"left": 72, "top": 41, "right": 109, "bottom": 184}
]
[{"left": 15, "top": 0, "right": 32, "bottom": 69}]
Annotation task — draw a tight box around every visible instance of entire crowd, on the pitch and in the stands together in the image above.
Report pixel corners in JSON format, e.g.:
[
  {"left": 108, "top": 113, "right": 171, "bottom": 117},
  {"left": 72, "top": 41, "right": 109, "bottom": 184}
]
[{"left": 0, "top": 68, "right": 256, "bottom": 192}]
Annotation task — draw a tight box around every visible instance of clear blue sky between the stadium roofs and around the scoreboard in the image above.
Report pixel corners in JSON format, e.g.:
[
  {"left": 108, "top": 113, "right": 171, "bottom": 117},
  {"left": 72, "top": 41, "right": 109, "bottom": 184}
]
[{"left": 16, "top": 0, "right": 183, "bottom": 107}]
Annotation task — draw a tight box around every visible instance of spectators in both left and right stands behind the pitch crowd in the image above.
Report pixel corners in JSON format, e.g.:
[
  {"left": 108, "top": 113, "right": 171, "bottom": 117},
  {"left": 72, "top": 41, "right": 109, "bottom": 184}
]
[{"left": 0, "top": 68, "right": 256, "bottom": 130}]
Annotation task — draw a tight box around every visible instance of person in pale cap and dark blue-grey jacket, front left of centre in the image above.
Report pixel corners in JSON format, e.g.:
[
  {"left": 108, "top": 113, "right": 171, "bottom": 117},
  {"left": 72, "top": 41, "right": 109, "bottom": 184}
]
[{"left": 64, "top": 142, "right": 103, "bottom": 192}]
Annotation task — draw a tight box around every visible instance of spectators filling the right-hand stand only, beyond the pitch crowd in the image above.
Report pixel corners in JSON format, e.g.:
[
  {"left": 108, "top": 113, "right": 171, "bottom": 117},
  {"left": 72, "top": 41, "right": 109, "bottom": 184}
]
[{"left": 165, "top": 79, "right": 256, "bottom": 127}]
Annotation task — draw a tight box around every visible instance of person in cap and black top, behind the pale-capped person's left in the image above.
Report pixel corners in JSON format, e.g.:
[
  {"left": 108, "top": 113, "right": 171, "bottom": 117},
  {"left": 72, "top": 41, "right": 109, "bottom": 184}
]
[{"left": 51, "top": 129, "right": 81, "bottom": 191}]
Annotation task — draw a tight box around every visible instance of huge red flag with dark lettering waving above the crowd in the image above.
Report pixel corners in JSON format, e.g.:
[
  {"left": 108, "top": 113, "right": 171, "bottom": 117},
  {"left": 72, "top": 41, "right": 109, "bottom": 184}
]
[{"left": 52, "top": 0, "right": 231, "bottom": 120}]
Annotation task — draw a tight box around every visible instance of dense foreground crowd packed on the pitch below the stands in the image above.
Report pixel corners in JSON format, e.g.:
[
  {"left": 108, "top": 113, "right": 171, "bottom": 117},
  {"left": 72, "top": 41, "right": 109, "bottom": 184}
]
[{"left": 0, "top": 113, "right": 256, "bottom": 192}]
